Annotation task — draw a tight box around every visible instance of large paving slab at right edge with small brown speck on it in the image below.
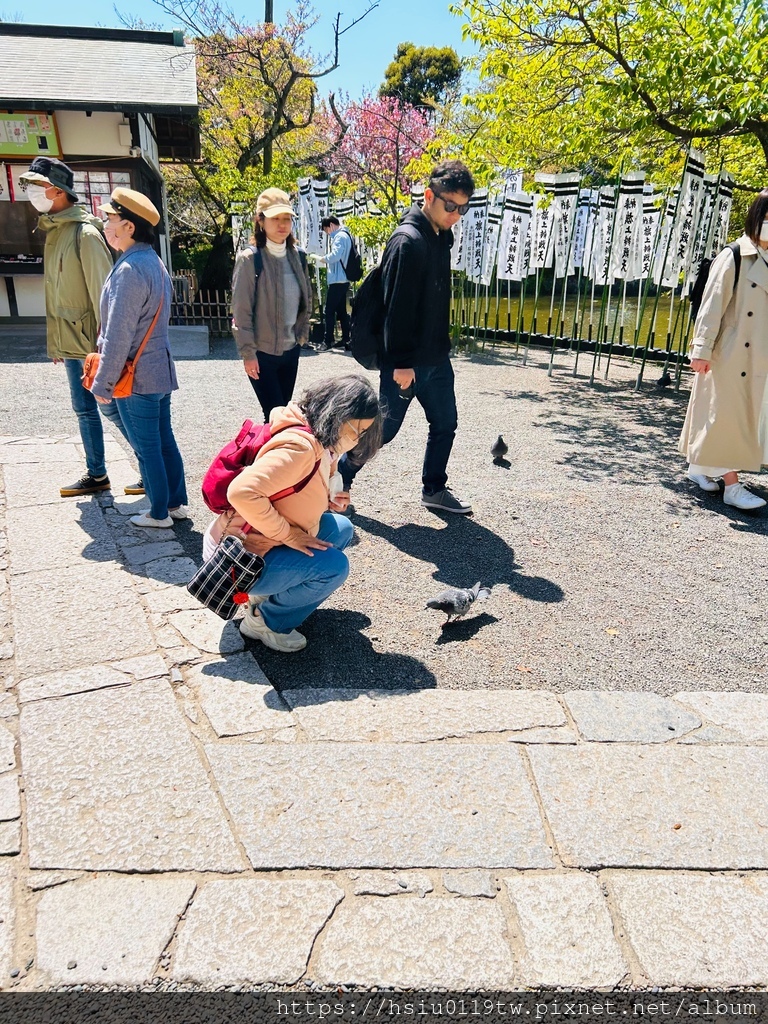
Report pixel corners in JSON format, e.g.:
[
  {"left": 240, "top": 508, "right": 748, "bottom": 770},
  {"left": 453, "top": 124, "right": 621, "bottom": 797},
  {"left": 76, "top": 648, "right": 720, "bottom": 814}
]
[{"left": 528, "top": 743, "right": 768, "bottom": 868}]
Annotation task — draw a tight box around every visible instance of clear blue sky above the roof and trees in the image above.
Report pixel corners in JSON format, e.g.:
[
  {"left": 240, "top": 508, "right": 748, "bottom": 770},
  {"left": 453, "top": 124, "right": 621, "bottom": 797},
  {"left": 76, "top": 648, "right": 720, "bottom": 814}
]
[{"left": 0, "top": 0, "right": 479, "bottom": 98}]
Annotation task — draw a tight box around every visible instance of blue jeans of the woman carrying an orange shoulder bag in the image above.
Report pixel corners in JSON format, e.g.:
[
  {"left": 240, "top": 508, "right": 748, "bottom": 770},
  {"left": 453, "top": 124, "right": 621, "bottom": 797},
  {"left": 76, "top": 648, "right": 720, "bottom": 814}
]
[{"left": 115, "top": 394, "right": 186, "bottom": 519}]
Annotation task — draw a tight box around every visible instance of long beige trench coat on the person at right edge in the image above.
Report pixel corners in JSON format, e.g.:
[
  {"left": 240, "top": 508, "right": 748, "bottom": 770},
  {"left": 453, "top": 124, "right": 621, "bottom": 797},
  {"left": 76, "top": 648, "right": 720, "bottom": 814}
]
[{"left": 679, "top": 234, "right": 768, "bottom": 472}]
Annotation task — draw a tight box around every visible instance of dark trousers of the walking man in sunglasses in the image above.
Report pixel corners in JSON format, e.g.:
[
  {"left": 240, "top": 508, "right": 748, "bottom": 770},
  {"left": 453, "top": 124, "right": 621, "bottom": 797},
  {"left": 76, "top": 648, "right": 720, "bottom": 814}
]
[{"left": 339, "top": 356, "right": 459, "bottom": 495}]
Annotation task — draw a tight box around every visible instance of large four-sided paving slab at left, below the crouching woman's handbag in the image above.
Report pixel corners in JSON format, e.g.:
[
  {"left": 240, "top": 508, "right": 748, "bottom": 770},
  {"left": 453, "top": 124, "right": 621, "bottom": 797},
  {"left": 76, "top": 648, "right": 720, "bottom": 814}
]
[{"left": 20, "top": 682, "right": 245, "bottom": 871}]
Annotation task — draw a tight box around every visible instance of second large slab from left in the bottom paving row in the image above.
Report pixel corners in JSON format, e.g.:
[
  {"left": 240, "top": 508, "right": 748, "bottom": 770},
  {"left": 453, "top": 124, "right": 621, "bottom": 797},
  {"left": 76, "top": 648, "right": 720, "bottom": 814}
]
[{"left": 172, "top": 879, "right": 344, "bottom": 987}]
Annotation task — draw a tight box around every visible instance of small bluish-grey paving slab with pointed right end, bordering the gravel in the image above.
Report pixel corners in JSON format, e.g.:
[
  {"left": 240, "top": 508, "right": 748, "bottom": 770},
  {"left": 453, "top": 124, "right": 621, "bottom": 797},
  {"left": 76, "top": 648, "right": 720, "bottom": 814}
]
[{"left": 563, "top": 690, "right": 701, "bottom": 743}]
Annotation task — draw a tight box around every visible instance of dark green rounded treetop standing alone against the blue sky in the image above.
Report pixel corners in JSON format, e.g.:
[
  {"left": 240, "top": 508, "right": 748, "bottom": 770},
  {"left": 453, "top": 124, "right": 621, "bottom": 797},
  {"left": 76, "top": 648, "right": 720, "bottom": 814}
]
[{"left": 379, "top": 43, "right": 462, "bottom": 106}]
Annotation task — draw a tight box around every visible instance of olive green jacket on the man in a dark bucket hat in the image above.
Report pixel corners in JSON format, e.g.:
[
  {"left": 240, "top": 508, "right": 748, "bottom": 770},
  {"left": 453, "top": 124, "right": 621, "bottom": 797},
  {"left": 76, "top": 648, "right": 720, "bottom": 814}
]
[{"left": 38, "top": 206, "right": 113, "bottom": 359}]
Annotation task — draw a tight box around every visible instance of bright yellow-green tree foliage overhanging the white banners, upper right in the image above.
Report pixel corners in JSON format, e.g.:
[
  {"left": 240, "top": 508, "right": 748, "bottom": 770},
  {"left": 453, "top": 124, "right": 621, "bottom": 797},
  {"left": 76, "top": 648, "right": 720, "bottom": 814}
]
[{"left": 453, "top": 0, "right": 768, "bottom": 187}]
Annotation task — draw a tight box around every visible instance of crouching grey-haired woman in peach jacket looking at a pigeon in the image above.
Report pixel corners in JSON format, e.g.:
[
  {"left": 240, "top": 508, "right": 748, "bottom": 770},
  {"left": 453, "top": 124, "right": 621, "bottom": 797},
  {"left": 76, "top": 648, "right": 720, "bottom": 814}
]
[{"left": 203, "top": 374, "right": 382, "bottom": 652}]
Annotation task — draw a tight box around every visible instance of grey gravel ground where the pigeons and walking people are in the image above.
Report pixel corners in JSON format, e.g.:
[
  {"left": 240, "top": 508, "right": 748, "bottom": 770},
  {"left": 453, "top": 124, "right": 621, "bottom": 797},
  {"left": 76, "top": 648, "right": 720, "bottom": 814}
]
[{"left": 0, "top": 334, "right": 768, "bottom": 694}]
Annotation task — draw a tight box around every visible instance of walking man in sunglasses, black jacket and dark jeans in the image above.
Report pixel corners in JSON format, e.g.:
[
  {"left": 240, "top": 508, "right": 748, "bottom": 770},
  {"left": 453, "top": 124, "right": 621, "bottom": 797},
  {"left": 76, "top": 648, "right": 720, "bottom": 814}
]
[{"left": 339, "top": 160, "right": 475, "bottom": 515}]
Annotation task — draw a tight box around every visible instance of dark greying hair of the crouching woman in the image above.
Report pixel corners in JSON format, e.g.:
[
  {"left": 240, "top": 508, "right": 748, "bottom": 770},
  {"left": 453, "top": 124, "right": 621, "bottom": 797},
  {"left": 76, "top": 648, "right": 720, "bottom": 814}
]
[{"left": 299, "top": 374, "right": 383, "bottom": 465}]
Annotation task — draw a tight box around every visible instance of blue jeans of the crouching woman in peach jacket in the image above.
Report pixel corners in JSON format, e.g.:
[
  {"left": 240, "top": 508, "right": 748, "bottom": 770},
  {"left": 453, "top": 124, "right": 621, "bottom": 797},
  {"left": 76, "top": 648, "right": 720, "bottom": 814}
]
[{"left": 251, "top": 512, "right": 353, "bottom": 633}]
